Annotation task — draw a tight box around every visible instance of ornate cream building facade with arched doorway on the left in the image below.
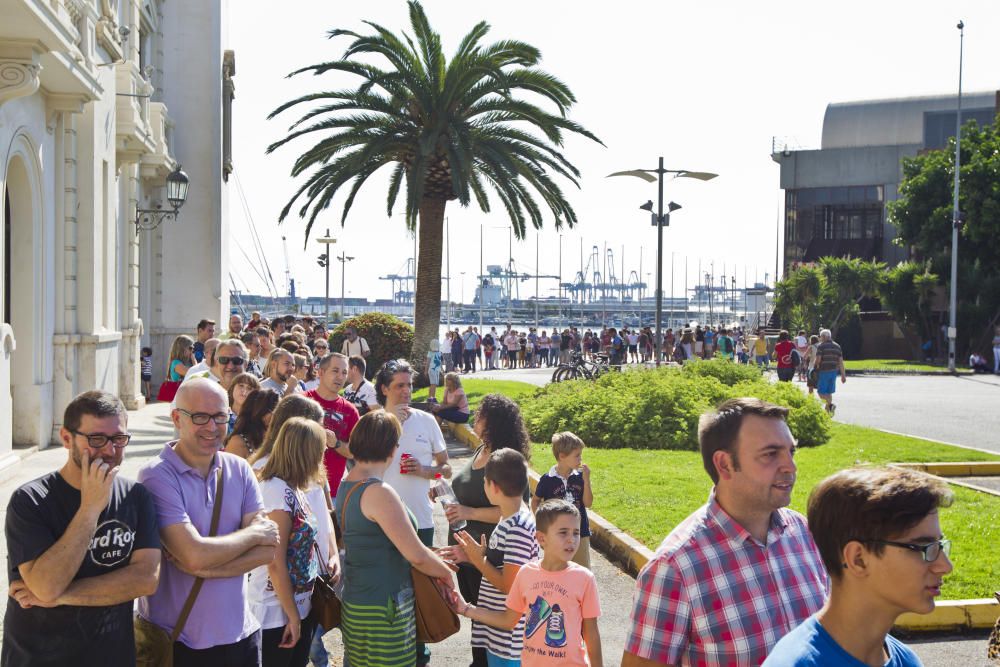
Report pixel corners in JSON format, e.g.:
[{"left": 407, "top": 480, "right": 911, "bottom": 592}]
[{"left": 0, "top": 0, "right": 235, "bottom": 475}]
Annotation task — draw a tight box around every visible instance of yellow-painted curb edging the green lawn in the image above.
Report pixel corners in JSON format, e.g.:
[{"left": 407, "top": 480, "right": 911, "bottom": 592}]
[{"left": 445, "top": 424, "right": 1000, "bottom": 633}]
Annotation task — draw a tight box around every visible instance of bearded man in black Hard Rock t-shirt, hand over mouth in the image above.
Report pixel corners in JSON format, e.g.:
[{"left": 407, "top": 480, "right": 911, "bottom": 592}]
[{"left": 0, "top": 391, "right": 160, "bottom": 666}]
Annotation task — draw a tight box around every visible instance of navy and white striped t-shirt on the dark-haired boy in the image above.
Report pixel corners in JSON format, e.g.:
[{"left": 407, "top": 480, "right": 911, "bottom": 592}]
[{"left": 472, "top": 506, "right": 538, "bottom": 660}]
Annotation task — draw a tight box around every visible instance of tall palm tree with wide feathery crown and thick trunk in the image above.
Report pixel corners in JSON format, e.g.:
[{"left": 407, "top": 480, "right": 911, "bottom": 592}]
[{"left": 267, "top": 0, "right": 600, "bottom": 366}]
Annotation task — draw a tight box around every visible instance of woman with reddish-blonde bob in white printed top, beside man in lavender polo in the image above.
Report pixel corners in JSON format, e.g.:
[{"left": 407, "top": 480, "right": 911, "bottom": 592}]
[{"left": 249, "top": 417, "right": 330, "bottom": 667}]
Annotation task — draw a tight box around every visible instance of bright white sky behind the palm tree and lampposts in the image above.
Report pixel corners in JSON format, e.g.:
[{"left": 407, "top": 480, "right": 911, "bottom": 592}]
[{"left": 227, "top": 0, "right": 1000, "bottom": 303}]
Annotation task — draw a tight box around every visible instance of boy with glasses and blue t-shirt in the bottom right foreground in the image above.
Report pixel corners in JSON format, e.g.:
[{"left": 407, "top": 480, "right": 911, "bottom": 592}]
[{"left": 764, "top": 468, "right": 952, "bottom": 667}]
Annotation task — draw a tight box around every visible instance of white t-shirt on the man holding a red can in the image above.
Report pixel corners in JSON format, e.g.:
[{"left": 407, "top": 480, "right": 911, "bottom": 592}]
[{"left": 382, "top": 410, "right": 446, "bottom": 528}]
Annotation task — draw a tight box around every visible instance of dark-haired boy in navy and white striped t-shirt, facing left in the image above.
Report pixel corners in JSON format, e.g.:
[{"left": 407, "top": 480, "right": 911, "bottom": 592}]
[{"left": 442, "top": 449, "right": 538, "bottom": 665}]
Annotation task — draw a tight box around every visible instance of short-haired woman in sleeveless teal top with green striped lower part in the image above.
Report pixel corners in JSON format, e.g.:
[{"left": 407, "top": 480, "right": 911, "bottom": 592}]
[{"left": 336, "top": 410, "right": 454, "bottom": 667}]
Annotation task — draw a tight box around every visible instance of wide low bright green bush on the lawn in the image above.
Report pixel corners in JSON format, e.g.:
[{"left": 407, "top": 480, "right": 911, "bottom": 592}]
[{"left": 521, "top": 360, "right": 831, "bottom": 450}]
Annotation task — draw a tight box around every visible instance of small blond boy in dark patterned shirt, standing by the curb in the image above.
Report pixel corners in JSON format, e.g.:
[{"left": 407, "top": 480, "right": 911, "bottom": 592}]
[{"left": 531, "top": 431, "right": 594, "bottom": 570}]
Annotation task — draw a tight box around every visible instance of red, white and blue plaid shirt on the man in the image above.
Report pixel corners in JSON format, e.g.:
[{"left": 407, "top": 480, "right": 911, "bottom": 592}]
[{"left": 625, "top": 489, "right": 828, "bottom": 667}]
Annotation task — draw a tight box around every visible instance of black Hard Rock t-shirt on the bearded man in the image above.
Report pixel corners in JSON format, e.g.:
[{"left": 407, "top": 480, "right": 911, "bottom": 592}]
[{"left": 0, "top": 472, "right": 160, "bottom": 667}]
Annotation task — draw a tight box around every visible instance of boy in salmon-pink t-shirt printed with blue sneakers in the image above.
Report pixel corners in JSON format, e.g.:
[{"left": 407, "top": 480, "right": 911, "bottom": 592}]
[{"left": 451, "top": 500, "right": 604, "bottom": 667}]
